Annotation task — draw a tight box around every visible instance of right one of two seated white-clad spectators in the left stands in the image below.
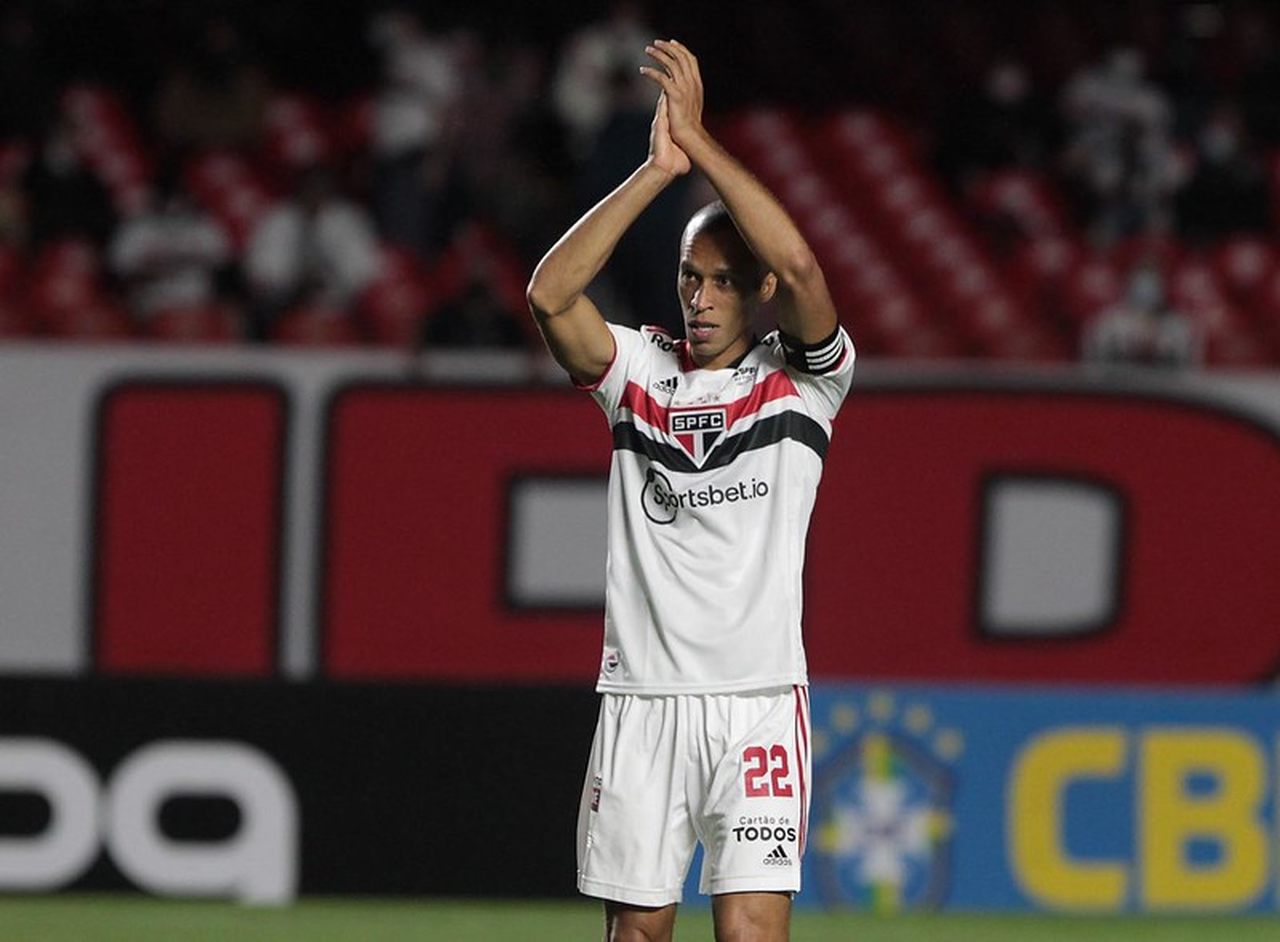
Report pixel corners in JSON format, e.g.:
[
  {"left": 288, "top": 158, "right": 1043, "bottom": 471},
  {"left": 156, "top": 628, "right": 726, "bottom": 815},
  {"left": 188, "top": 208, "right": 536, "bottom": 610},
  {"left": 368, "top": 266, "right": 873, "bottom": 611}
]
[{"left": 244, "top": 165, "right": 380, "bottom": 339}]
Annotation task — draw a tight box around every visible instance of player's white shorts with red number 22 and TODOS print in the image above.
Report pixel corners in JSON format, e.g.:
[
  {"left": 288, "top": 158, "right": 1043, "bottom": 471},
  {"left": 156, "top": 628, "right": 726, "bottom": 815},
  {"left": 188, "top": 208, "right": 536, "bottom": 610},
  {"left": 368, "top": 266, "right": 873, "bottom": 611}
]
[{"left": 577, "top": 686, "right": 810, "bottom": 906}]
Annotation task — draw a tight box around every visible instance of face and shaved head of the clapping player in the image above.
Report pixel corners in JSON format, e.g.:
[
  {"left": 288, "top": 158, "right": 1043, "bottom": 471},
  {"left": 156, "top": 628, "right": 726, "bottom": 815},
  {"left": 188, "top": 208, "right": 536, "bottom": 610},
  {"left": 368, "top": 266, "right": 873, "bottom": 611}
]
[{"left": 677, "top": 229, "right": 772, "bottom": 370}]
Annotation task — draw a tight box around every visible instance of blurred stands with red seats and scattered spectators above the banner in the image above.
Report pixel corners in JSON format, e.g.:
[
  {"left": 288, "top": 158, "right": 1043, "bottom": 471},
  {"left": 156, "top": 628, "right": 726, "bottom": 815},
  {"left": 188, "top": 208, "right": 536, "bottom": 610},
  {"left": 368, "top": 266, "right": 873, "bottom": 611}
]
[{"left": 0, "top": 0, "right": 1280, "bottom": 366}]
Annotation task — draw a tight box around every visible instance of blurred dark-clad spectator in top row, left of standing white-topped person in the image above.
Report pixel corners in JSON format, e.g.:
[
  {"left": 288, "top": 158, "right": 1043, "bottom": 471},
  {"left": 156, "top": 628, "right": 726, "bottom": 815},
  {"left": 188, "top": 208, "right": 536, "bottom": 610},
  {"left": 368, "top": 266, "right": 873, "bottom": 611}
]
[{"left": 152, "top": 15, "right": 270, "bottom": 155}]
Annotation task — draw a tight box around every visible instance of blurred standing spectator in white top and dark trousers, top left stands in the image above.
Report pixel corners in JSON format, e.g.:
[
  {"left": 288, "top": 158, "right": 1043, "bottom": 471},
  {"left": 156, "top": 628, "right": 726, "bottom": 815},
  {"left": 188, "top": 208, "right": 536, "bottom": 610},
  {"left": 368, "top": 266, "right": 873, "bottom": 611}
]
[{"left": 369, "top": 6, "right": 463, "bottom": 259}]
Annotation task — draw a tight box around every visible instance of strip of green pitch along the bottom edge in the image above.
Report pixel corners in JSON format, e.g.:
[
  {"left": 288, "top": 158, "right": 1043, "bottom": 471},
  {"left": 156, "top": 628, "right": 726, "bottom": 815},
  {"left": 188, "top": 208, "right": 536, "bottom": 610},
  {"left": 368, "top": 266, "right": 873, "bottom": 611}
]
[{"left": 0, "top": 896, "right": 1280, "bottom": 942}]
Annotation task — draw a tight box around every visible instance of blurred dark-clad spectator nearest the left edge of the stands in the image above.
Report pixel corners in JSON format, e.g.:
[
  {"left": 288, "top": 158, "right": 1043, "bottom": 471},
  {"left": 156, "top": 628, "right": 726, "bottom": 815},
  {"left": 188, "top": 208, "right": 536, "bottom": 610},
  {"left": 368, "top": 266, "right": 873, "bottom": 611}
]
[{"left": 22, "top": 111, "right": 115, "bottom": 251}]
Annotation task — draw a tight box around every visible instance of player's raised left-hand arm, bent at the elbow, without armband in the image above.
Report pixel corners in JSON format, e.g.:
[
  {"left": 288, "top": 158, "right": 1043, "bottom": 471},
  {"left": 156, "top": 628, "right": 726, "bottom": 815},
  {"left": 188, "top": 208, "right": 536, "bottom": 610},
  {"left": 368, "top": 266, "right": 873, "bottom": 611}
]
[{"left": 527, "top": 96, "right": 690, "bottom": 385}]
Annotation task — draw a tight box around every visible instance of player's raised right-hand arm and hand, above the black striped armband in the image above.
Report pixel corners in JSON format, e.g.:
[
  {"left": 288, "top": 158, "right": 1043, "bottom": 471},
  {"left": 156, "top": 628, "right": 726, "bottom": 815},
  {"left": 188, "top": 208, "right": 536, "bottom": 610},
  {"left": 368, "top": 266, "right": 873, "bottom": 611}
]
[{"left": 640, "top": 40, "right": 837, "bottom": 344}]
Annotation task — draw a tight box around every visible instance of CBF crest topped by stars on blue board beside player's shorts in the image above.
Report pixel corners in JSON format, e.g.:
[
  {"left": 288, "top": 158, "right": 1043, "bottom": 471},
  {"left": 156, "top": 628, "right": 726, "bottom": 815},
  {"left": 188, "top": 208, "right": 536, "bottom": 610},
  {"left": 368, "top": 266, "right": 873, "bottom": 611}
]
[{"left": 806, "top": 692, "right": 964, "bottom": 913}]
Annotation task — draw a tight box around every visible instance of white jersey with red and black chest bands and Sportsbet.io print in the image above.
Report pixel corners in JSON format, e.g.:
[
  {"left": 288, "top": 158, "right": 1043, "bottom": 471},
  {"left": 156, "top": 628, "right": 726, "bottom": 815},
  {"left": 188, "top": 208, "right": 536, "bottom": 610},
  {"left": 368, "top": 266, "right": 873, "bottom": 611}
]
[{"left": 590, "top": 324, "right": 854, "bottom": 694}]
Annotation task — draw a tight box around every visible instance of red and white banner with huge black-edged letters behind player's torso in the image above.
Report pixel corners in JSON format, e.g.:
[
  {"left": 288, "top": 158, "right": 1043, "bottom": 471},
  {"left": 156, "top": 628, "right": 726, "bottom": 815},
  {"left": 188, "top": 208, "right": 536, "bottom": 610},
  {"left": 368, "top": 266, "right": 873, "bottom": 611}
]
[{"left": 0, "top": 346, "right": 1280, "bottom": 683}]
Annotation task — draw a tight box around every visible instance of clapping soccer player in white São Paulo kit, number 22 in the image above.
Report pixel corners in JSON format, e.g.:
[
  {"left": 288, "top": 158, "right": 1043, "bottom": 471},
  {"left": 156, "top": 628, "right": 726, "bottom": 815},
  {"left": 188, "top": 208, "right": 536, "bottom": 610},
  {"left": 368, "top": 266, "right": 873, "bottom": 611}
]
[{"left": 529, "top": 40, "right": 854, "bottom": 942}]
